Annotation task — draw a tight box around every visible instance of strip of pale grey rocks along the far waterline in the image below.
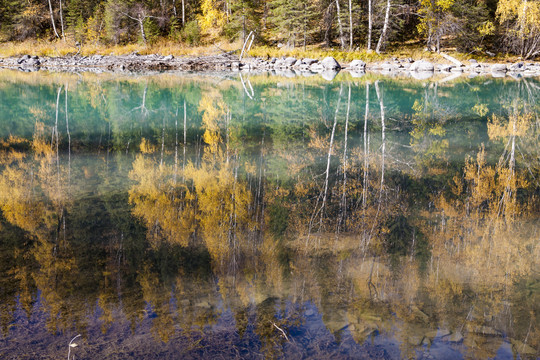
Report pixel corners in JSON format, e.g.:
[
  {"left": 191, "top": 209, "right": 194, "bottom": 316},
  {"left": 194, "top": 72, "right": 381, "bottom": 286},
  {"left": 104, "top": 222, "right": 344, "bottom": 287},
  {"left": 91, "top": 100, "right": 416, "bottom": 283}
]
[{"left": 0, "top": 53, "right": 540, "bottom": 80}]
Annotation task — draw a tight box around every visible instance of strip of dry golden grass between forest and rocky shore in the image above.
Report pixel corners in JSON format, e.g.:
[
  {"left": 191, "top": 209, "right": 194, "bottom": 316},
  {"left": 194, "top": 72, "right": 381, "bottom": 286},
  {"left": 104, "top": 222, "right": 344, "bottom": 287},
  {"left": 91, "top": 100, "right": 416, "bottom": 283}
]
[{"left": 0, "top": 40, "right": 518, "bottom": 62}]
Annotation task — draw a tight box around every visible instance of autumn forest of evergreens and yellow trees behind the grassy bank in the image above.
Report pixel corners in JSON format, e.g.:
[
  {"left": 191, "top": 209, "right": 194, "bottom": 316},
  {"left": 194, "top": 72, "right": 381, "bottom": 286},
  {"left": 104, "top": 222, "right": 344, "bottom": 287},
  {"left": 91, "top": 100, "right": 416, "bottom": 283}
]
[{"left": 0, "top": 0, "right": 540, "bottom": 59}]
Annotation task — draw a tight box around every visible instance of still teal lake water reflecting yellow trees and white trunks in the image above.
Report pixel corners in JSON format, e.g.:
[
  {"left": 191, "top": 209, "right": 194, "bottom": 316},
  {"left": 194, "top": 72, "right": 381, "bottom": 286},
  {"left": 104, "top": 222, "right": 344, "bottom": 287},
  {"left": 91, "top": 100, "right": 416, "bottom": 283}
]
[{"left": 0, "top": 71, "right": 540, "bottom": 359}]
